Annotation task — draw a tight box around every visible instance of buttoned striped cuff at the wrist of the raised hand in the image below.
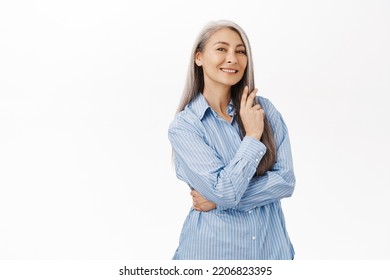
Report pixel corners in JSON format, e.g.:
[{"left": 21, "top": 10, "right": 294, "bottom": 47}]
[{"left": 236, "top": 136, "right": 267, "bottom": 167}]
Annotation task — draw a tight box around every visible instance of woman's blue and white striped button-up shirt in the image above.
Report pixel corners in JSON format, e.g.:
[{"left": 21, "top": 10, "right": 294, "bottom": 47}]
[{"left": 168, "top": 94, "right": 295, "bottom": 260}]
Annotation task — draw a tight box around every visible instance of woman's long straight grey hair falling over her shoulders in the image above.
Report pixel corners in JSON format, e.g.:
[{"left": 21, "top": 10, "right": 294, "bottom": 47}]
[{"left": 177, "top": 20, "right": 276, "bottom": 176}]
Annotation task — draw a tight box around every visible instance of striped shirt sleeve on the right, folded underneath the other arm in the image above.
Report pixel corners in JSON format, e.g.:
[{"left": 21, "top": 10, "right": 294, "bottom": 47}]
[{"left": 236, "top": 108, "right": 295, "bottom": 211}]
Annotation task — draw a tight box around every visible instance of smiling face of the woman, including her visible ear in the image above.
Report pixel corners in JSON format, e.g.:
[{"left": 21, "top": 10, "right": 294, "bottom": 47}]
[{"left": 195, "top": 28, "right": 248, "bottom": 87}]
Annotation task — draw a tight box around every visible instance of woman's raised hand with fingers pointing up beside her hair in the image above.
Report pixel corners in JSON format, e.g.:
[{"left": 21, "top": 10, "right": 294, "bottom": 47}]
[{"left": 240, "top": 86, "right": 265, "bottom": 140}]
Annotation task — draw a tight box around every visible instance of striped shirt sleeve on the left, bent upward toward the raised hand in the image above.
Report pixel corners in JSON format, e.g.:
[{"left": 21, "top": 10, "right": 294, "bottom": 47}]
[{"left": 168, "top": 118, "right": 266, "bottom": 207}]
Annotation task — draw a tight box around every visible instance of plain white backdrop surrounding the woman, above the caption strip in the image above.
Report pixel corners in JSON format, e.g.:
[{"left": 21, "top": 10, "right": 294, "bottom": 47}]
[{"left": 0, "top": 0, "right": 390, "bottom": 260}]
